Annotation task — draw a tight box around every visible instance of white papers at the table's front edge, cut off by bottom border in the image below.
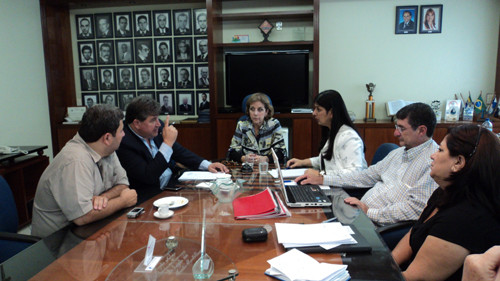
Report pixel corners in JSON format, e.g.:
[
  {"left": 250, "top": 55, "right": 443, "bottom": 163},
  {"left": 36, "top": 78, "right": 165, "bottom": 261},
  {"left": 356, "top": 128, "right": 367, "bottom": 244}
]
[{"left": 265, "top": 249, "right": 350, "bottom": 281}]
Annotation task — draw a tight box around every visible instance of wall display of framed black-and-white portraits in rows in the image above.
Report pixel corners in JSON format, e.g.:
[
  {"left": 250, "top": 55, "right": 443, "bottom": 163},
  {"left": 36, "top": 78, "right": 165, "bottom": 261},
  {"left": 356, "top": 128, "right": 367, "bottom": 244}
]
[{"left": 70, "top": 3, "right": 210, "bottom": 116}]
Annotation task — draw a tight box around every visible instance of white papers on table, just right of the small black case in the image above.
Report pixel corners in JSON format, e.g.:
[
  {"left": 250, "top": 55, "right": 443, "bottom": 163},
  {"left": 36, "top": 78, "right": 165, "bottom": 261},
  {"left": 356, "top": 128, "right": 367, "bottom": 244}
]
[{"left": 275, "top": 222, "right": 357, "bottom": 250}]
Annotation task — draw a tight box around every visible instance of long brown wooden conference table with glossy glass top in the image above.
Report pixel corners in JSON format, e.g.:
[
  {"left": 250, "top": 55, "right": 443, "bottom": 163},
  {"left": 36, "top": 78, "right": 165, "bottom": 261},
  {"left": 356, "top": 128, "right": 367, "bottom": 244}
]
[{"left": 0, "top": 165, "right": 404, "bottom": 280}]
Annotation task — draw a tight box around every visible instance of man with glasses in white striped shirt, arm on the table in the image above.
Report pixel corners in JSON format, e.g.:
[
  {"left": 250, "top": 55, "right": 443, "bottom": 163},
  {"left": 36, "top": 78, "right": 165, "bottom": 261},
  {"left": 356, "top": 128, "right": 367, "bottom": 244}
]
[{"left": 296, "top": 103, "right": 438, "bottom": 225}]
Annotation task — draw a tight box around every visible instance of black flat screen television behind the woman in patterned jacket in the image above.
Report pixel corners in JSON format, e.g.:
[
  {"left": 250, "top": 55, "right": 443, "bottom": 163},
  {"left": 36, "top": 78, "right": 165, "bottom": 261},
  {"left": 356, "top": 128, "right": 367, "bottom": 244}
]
[{"left": 225, "top": 50, "right": 310, "bottom": 112}]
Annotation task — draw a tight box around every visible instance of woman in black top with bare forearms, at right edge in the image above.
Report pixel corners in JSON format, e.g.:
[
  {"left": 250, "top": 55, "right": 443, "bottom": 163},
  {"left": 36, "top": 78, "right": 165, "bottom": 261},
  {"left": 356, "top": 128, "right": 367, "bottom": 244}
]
[{"left": 392, "top": 125, "right": 500, "bottom": 280}]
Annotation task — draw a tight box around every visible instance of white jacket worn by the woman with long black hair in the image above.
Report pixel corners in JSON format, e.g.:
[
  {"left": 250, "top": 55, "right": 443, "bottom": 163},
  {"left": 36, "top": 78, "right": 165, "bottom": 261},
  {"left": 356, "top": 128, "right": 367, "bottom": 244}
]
[{"left": 309, "top": 125, "right": 368, "bottom": 176}]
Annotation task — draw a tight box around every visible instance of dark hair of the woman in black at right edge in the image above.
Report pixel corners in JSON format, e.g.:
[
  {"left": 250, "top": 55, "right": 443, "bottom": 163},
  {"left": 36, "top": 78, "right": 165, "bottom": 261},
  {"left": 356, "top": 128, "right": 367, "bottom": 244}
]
[{"left": 442, "top": 125, "right": 500, "bottom": 218}]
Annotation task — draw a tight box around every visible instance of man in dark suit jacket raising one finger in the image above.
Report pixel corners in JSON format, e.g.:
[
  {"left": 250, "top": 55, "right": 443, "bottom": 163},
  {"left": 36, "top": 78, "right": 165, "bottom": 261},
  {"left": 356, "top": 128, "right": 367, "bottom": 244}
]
[{"left": 116, "top": 96, "right": 229, "bottom": 202}]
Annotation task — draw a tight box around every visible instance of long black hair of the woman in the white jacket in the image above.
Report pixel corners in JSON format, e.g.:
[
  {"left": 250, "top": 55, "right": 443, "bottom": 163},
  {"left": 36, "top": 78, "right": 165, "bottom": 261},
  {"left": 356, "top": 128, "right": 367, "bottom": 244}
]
[{"left": 314, "top": 90, "right": 366, "bottom": 160}]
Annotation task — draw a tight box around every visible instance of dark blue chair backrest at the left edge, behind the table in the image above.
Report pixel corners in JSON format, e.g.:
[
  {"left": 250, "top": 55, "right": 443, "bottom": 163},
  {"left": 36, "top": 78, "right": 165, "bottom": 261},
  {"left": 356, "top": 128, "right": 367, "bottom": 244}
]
[{"left": 0, "top": 176, "right": 19, "bottom": 233}]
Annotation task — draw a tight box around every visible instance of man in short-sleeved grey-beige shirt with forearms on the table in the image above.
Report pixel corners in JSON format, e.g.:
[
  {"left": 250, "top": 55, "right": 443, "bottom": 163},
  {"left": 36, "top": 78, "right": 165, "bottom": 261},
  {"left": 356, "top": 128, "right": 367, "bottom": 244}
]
[{"left": 32, "top": 105, "right": 137, "bottom": 237}]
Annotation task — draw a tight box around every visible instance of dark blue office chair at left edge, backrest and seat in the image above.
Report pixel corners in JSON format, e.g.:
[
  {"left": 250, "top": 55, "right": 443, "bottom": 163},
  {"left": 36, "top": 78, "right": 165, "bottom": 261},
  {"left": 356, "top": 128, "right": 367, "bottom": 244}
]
[{"left": 0, "top": 176, "right": 40, "bottom": 263}]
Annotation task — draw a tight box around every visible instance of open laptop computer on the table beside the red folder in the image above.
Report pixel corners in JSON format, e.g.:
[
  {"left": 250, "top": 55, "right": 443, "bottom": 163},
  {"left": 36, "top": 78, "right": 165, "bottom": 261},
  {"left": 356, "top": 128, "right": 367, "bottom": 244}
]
[{"left": 271, "top": 148, "right": 332, "bottom": 207}]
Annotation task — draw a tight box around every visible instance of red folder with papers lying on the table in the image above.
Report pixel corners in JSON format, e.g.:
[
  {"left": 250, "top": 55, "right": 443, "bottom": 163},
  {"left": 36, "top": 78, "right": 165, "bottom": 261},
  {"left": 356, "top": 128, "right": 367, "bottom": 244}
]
[{"left": 233, "top": 188, "right": 291, "bottom": 219}]
